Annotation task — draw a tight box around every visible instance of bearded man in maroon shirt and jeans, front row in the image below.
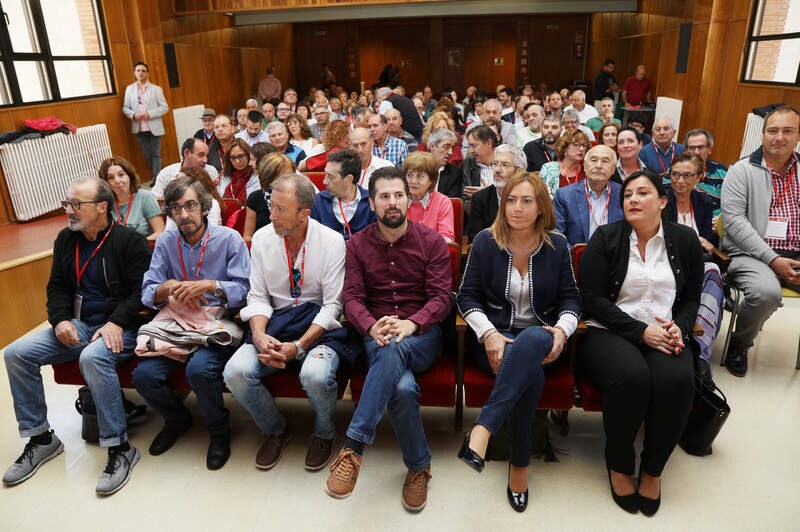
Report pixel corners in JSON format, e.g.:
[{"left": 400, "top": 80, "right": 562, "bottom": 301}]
[{"left": 325, "top": 167, "right": 452, "bottom": 511}]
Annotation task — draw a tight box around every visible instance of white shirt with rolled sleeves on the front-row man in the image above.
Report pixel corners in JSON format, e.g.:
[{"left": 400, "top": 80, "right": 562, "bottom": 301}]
[{"left": 240, "top": 218, "right": 345, "bottom": 331}]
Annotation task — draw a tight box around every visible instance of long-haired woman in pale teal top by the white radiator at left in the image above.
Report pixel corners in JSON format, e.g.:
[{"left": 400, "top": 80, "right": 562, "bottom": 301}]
[{"left": 97, "top": 157, "right": 164, "bottom": 240}]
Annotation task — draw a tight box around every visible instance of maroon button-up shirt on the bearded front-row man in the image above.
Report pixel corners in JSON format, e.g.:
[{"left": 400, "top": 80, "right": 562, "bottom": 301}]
[{"left": 342, "top": 222, "right": 452, "bottom": 336}]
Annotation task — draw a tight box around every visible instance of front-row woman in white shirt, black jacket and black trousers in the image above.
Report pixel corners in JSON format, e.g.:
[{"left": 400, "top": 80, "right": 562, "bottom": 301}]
[{"left": 576, "top": 171, "right": 703, "bottom": 516}]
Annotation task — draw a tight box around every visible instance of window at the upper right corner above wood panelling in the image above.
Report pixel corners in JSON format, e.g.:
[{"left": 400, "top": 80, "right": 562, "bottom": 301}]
[{"left": 742, "top": 0, "right": 800, "bottom": 85}]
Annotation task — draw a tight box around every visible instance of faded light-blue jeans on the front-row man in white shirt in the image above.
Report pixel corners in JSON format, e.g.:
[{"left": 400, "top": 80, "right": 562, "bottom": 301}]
[{"left": 222, "top": 343, "right": 339, "bottom": 440}]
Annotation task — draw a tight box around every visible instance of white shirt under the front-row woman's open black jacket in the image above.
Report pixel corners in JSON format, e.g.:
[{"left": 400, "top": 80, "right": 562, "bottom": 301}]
[{"left": 617, "top": 226, "right": 677, "bottom": 325}]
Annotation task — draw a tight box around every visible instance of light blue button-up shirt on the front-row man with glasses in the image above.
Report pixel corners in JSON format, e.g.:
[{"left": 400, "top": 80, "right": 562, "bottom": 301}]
[{"left": 142, "top": 225, "right": 250, "bottom": 308}]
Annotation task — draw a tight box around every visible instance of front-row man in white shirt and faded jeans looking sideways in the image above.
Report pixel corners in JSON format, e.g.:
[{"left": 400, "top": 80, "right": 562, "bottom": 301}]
[{"left": 223, "top": 174, "right": 356, "bottom": 471}]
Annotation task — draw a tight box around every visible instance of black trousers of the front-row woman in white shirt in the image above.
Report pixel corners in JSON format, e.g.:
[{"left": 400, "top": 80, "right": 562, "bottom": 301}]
[{"left": 576, "top": 327, "right": 694, "bottom": 477}]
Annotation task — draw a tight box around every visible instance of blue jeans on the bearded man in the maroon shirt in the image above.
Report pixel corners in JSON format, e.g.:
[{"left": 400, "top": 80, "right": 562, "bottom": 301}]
[{"left": 347, "top": 325, "right": 442, "bottom": 471}]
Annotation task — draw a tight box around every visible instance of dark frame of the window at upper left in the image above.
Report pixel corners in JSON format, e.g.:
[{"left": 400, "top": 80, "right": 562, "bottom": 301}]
[{"left": 0, "top": 0, "right": 117, "bottom": 109}]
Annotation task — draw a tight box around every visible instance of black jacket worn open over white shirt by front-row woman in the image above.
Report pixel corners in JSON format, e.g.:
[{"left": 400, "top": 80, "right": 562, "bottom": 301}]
[{"left": 577, "top": 220, "right": 703, "bottom": 343}]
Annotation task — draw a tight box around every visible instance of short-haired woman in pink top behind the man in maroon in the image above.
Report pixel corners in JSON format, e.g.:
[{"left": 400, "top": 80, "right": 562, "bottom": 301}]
[{"left": 403, "top": 151, "right": 455, "bottom": 243}]
